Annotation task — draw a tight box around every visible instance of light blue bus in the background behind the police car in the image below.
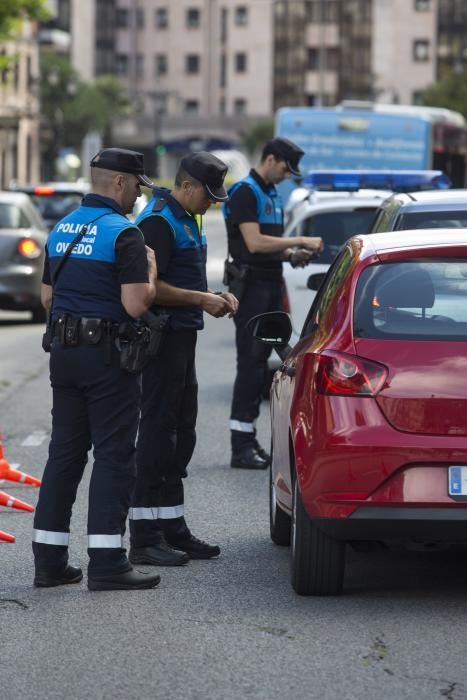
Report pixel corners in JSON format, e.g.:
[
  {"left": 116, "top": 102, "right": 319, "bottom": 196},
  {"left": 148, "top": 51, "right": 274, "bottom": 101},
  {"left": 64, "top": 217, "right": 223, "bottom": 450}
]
[{"left": 275, "top": 101, "right": 467, "bottom": 187}]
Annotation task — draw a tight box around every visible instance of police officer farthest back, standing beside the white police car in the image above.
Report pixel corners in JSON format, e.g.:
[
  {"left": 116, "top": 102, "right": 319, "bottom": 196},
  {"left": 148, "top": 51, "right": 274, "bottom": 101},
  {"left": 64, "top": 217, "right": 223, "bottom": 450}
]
[{"left": 224, "top": 138, "right": 323, "bottom": 469}]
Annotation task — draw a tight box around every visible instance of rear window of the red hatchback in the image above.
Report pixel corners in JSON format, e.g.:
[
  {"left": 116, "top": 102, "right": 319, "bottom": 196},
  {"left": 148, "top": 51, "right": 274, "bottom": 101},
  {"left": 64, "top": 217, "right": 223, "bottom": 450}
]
[{"left": 354, "top": 259, "right": 467, "bottom": 340}]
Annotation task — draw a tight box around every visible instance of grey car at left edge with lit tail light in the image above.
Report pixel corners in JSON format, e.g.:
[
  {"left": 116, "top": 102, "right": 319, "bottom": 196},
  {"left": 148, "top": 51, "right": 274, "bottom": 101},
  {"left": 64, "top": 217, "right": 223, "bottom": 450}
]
[{"left": 0, "top": 192, "right": 47, "bottom": 322}]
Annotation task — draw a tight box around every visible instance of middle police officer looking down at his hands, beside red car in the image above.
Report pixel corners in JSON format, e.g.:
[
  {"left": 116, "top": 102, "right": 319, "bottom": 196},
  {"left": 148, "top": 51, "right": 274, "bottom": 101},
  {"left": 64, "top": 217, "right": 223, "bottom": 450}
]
[{"left": 129, "top": 151, "right": 237, "bottom": 566}]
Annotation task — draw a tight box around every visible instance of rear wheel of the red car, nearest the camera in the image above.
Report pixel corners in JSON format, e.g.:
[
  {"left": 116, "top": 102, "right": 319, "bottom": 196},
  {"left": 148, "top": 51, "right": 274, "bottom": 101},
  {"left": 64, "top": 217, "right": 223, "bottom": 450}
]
[{"left": 290, "top": 479, "right": 345, "bottom": 595}]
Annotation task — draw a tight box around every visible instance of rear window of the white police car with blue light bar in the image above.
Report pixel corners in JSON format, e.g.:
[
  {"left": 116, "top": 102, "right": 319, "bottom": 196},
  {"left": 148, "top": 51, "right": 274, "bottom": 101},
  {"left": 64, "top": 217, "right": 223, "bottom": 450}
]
[{"left": 303, "top": 207, "right": 376, "bottom": 263}]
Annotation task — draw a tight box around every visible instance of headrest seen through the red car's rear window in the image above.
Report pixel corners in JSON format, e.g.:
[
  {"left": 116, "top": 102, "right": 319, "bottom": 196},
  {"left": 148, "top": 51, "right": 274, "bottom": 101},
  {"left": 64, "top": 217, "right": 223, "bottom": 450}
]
[{"left": 375, "top": 265, "right": 435, "bottom": 309}]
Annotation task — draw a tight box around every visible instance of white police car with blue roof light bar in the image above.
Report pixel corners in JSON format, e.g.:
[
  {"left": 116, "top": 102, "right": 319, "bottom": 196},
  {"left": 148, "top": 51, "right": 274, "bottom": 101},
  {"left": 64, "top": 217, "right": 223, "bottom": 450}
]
[{"left": 284, "top": 170, "right": 451, "bottom": 343}]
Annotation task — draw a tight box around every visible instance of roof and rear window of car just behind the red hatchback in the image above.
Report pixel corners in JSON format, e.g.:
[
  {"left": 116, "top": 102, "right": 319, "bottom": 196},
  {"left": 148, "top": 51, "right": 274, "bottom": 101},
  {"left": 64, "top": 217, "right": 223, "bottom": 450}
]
[{"left": 370, "top": 190, "right": 467, "bottom": 233}]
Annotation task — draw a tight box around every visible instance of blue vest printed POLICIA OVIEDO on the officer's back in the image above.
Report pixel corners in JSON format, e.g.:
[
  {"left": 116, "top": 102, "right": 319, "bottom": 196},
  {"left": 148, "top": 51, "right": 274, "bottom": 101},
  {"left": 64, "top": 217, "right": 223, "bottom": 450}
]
[{"left": 47, "top": 206, "right": 137, "bottom": 321}]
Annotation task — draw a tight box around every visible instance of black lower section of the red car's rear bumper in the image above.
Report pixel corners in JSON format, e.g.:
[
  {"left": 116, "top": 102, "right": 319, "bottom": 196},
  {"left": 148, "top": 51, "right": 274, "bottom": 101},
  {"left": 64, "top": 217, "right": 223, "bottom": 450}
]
[{"left": 313, "top": 506, "right": 467, "bottom": 544}]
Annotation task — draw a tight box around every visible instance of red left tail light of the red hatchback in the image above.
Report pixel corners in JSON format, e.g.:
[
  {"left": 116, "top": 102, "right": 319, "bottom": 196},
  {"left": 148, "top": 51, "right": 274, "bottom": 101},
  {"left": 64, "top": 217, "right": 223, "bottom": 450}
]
[{"left": 315, "top": 352, "right": 388, "bottom": 396}]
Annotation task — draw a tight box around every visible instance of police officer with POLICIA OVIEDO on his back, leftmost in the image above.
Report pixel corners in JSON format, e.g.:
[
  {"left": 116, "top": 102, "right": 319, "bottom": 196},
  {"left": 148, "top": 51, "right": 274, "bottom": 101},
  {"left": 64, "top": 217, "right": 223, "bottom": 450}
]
[{"left": 33, "top": 148, "right": 159, "bottom": 590}]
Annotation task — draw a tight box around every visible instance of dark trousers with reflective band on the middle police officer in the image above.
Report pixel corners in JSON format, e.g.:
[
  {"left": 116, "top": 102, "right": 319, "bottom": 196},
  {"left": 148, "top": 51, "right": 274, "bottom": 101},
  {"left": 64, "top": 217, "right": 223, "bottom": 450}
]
[{"left": 129, "top": 330, "right": 198, "bottom": 547}]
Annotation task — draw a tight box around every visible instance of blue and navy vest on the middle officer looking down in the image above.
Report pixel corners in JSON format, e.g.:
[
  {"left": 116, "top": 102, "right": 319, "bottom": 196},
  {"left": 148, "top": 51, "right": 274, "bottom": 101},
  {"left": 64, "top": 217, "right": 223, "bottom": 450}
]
[{"left": 136, "top": 187, "right": 208, "bottom": 330}]
